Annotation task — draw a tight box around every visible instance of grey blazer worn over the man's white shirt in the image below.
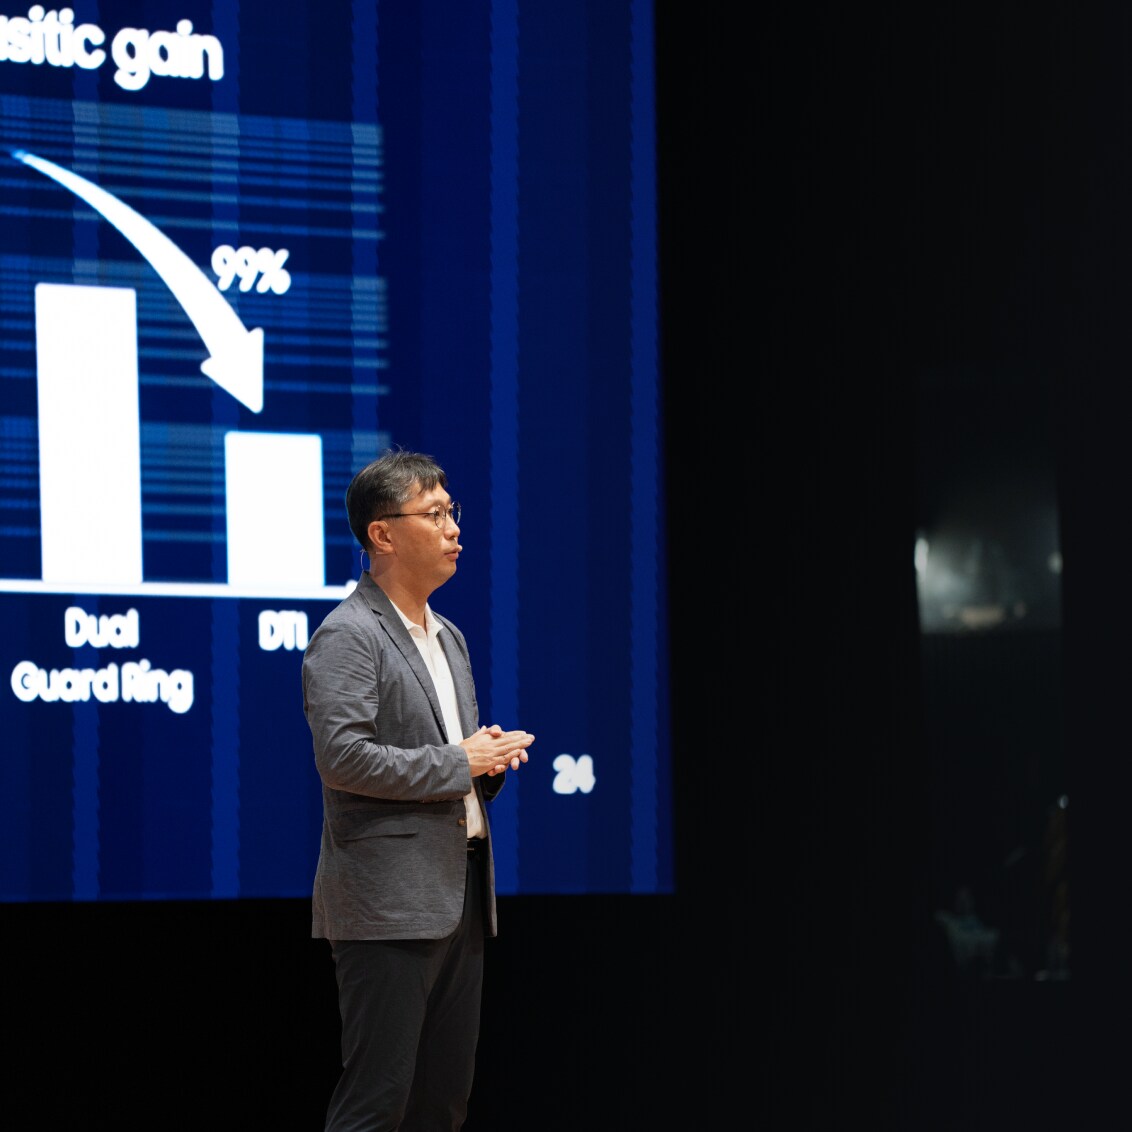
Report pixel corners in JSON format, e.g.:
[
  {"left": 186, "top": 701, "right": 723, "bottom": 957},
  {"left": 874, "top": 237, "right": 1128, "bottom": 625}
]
[{"left": 302, "top": 574, "right": 505, "bottom": 940}]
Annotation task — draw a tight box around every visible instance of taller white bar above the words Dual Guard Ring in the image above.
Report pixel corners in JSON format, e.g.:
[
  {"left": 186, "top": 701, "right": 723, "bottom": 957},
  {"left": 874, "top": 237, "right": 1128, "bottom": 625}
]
[{"left": 35, "top": 283, "right": 142, "bottom": 584}]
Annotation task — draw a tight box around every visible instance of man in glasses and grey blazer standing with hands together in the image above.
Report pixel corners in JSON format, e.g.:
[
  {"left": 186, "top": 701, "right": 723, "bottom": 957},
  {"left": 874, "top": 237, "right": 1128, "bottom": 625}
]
[{"left": 302, "top": 451, "right": 534, "bottom": 1132}]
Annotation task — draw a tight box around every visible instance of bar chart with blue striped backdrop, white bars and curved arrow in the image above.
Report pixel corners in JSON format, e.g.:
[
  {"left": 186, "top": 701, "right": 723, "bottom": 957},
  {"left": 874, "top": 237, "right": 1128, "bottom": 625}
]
[{"left": 0, "top": 96, "right": 385, "bottom": 599}]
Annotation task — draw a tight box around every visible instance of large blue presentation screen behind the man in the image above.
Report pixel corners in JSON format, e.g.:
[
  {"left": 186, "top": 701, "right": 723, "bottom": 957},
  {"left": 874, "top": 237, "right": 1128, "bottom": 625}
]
[{"left": 0, "top": 0, "right": 674, "bottom": 902}]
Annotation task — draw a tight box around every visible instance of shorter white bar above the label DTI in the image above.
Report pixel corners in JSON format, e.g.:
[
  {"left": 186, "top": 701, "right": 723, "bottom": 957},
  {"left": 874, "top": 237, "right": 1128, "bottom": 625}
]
[{"left": 224, "top": 432, "right": 326, "bottom": 591}]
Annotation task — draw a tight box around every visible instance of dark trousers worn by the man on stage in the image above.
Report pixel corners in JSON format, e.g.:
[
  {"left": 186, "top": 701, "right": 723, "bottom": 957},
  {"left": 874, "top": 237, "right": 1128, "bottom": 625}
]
[{"left": 326, "top": 854, "right": 483, "bottom": 1132}]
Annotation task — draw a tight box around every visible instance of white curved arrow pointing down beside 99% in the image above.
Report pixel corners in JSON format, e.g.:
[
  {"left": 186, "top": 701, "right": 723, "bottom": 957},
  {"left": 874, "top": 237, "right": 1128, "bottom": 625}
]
[{"left": 12, "top": 149, "right": 264, "bottom": 413}]
